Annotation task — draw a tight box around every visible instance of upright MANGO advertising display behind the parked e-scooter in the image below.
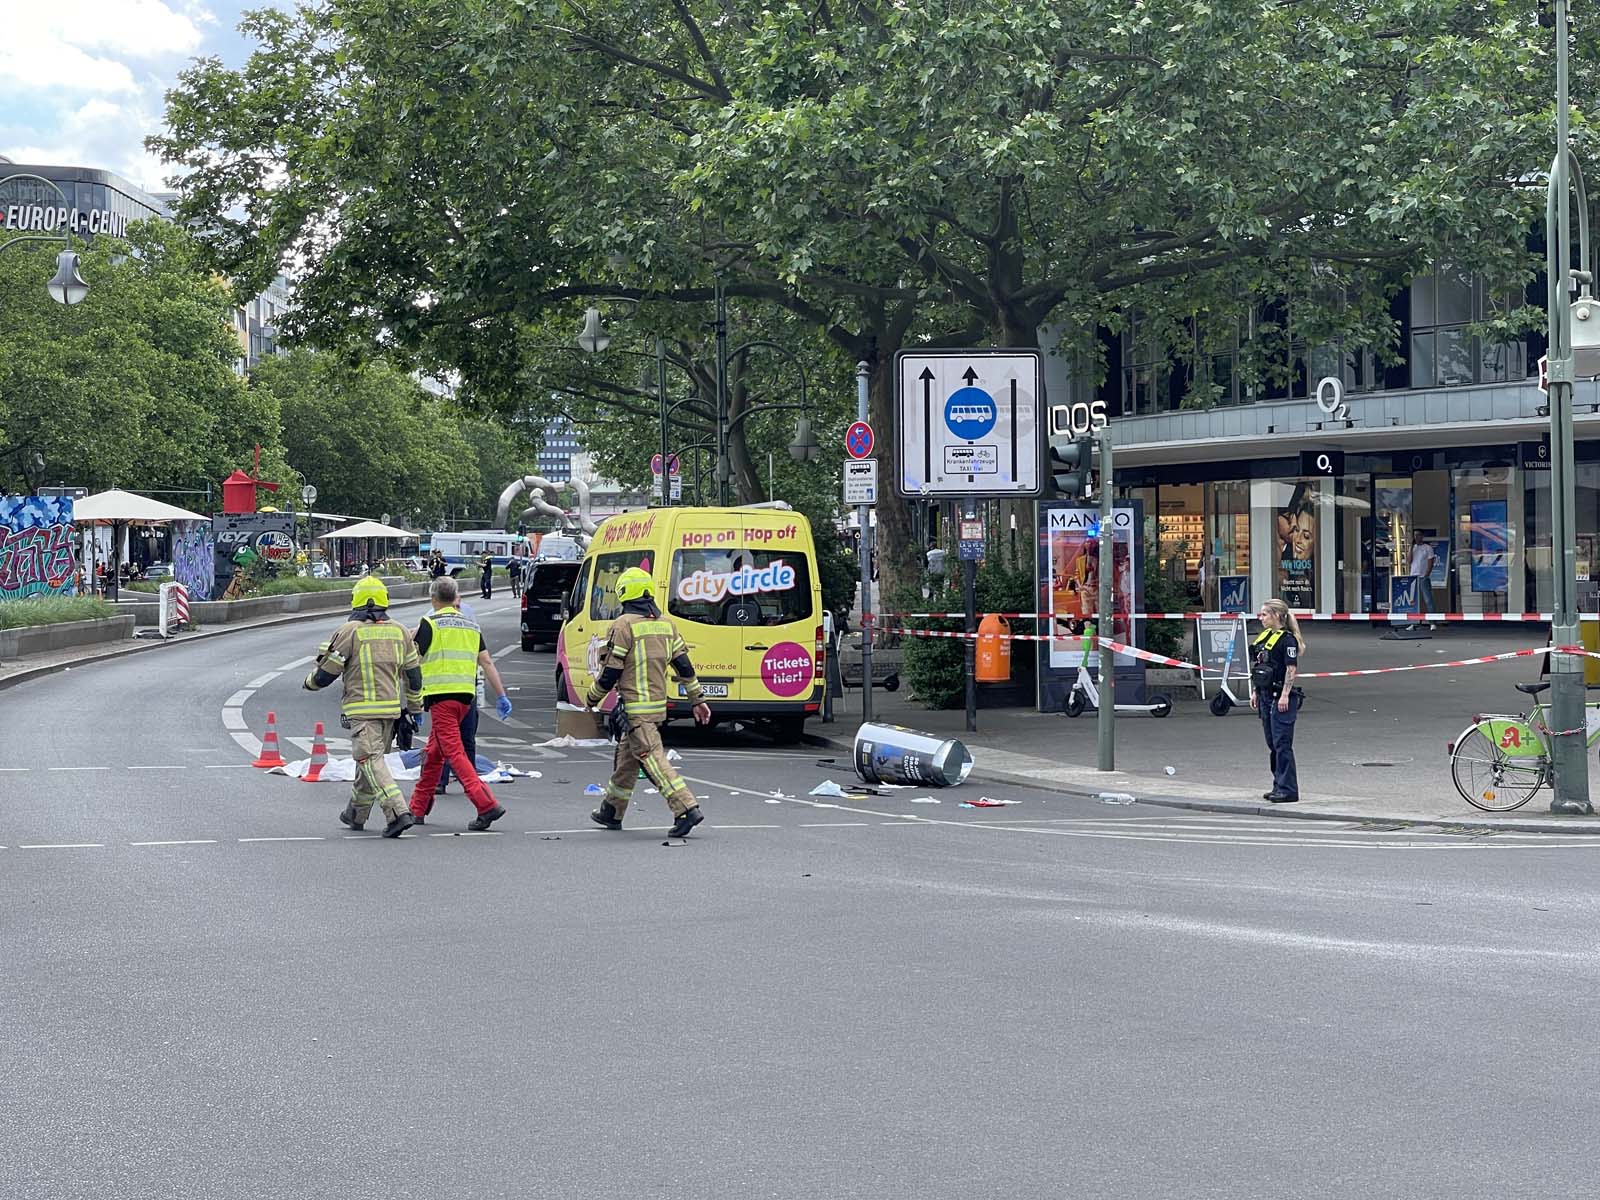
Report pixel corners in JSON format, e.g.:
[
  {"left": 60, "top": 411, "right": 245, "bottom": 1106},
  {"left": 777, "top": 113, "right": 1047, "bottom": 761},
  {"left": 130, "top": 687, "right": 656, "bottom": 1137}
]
[{"left": 1037, "top": 501, "right": 1144, "bottom": 712}]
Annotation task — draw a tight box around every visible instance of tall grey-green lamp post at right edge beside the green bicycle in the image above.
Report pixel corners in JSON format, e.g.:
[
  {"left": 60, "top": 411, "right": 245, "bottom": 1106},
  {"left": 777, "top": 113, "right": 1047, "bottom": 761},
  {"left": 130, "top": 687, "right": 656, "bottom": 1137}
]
[{"left": 1544, "top": 0, "right": 1600, "bottom": 813}]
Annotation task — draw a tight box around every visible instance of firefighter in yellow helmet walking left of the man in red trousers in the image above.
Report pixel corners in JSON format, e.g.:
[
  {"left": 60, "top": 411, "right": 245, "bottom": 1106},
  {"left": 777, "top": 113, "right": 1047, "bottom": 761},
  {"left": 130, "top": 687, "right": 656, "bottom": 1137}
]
[{"left": 306, "top": 574, "right": 422, "bottom": 837}]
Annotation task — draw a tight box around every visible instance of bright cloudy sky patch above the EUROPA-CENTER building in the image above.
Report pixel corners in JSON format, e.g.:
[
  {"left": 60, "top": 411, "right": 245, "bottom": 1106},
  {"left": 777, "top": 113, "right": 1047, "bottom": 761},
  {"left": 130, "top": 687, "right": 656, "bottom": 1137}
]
[{"left": 0, "top": 0, "right": 270, "bottom": 189}]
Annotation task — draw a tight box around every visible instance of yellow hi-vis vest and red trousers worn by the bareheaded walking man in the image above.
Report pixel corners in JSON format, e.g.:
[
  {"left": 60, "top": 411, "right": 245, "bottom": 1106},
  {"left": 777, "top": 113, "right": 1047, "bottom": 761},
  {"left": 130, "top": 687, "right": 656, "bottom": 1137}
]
[{"left": 411, "top": 606, "right": 506, "bottom": 832}]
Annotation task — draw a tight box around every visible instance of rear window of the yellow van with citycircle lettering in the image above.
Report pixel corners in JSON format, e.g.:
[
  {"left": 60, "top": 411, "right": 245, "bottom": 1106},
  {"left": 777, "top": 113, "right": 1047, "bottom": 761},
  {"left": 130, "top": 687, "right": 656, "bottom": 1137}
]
[{"left": 667, "top": 549, "right": 813, "bottom": 626}]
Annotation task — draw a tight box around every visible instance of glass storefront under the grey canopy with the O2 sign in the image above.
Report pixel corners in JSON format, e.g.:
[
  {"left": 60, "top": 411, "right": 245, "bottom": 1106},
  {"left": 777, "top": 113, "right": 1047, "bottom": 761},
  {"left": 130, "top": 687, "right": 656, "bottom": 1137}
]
[{"left": 1118, "top": 446, "right": 1574, "bottom": 613}]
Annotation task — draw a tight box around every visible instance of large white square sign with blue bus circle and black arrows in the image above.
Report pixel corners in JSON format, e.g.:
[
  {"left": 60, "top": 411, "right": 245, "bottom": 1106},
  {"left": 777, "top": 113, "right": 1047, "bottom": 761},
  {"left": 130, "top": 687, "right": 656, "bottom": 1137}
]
[{"left": 894, "top": 350, "right": 1045, "bottom": 499}]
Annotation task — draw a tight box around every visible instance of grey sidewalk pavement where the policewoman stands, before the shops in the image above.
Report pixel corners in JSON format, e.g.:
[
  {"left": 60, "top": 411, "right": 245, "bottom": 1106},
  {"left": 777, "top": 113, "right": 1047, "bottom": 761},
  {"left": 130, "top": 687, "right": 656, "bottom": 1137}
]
[{"left": 808, "top": 622, "right": 1600, "bottom": 834}]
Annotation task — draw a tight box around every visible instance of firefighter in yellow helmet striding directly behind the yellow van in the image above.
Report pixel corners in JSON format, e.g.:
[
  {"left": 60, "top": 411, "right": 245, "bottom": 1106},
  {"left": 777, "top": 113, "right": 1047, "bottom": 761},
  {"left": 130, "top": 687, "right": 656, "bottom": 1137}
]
[{"left": 584, "top": 566, "right": 710, "bottom": 837}]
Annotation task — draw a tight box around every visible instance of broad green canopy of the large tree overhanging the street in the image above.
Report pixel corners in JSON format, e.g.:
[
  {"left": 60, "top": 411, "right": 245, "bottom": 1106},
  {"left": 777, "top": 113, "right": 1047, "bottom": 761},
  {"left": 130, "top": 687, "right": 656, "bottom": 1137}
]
[{"left": 152, "top": 0, "right": 1552, "bottom": 588}]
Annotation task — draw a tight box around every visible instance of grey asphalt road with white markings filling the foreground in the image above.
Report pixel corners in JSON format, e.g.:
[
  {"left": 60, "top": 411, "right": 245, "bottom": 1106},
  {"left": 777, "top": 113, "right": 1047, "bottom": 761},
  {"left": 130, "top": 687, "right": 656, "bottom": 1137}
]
[{"left": 0, "top": 598, "right": 1600, "bottom": 1200}]
